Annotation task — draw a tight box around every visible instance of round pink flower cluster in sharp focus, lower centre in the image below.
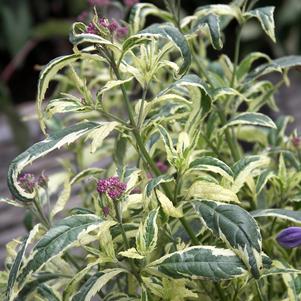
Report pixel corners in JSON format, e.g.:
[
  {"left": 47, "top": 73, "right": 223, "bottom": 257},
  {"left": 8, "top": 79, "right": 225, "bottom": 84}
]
[{"left": 97, "top": 177, "right": 126, "bottom": 200}]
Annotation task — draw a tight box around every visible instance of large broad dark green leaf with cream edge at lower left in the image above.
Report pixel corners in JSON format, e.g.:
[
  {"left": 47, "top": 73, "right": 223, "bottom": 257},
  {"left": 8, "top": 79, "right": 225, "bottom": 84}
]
[{"left": 17, "top": 214, "right": 116, "bottom": 283}]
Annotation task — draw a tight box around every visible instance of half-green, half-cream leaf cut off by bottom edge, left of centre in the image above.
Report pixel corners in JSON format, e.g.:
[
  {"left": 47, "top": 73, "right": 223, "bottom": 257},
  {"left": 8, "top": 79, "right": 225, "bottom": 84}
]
[{"left": 71, "top": 269, "right": 125, "bottom": 301}]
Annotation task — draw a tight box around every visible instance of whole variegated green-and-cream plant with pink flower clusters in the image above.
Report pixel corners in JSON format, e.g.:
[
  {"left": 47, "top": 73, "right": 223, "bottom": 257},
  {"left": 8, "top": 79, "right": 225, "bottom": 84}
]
[{"left": 0, "top": 0, "right": 301, "bottom": 301}]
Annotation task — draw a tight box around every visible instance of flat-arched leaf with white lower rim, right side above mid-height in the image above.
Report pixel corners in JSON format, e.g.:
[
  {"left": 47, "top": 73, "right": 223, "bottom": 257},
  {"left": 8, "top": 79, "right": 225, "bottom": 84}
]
[{"left": 223, "top": 112, "right": 277, "bottom": 129}]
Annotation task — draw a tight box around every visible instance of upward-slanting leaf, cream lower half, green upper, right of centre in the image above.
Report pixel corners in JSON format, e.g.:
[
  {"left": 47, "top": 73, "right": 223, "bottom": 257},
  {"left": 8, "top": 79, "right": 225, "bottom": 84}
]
[{"left": 231, "top": 156, "right": 270, "bottom": 193}]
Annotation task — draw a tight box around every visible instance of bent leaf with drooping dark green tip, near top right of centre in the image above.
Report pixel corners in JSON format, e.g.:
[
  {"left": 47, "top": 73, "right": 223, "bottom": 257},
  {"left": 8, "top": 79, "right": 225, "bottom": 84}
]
[{"left": 192, "top": 14, "right": 223, "bottom": 50}]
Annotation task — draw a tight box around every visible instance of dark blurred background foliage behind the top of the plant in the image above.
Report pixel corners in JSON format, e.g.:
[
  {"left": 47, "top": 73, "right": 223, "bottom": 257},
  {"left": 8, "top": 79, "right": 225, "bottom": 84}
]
[{"left": 0, "top": 0, "right": 301, "bottom": 149}]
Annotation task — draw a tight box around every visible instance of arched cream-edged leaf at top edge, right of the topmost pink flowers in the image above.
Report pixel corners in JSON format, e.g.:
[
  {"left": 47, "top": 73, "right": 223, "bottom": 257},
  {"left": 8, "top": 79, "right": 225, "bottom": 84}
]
[{"left": 129, "top": 3, "right": 172, "bottom": 33}]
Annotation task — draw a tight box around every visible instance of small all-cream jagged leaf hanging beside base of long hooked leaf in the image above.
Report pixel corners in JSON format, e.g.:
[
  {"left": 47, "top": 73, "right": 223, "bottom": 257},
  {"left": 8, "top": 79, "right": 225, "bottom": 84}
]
[{"left": 87, "top": 121, "right": 120, "bottom": 154}]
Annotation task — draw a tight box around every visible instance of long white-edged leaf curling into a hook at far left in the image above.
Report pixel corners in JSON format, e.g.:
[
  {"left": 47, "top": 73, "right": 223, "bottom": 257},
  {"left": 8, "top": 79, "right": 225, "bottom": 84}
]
[{"left": 7, "top": 122, "right": 100, "bottom": 202}]
